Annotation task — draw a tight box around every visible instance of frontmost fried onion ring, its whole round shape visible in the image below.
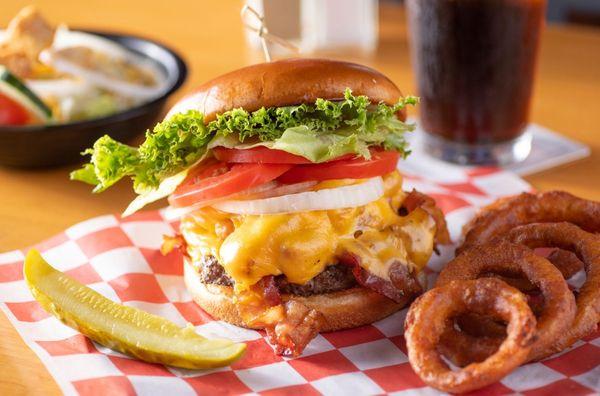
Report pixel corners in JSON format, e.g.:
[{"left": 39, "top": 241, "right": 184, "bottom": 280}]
[{"left": 405, "top": 278, "right": 536, "bottom": 392}]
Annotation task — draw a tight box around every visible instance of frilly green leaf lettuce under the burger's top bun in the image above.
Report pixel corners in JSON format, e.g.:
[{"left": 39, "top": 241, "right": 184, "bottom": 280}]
[{"left": 71, "top": 89, "right": 418, "bottom": 210}]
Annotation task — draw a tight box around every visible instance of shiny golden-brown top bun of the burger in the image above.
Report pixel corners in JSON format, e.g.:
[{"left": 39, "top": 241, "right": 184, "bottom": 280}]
[{"left": 167, "top": 58, "right": 406, "bottom": 122}]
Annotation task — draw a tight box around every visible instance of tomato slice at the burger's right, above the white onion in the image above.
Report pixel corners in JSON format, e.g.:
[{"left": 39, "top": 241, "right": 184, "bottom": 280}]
[{"left": 277, "top": 150, "right": 400, "bottom": 184}]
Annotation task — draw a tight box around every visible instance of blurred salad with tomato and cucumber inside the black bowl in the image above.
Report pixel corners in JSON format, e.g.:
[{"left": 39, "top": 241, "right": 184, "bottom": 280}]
[{"left": 0, "top": 6, "right": 175, "bottom": 126}]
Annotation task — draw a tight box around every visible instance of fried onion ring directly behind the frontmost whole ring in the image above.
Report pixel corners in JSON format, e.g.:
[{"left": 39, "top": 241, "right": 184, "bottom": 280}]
[{"left": 436, "top": 241, "right": 577, "bottom": 364}]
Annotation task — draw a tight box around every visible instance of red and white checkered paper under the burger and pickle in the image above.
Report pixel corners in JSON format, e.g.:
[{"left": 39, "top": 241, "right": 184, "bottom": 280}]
[{"left": 0, "top": 160, "right": 600, "bottom": 395}]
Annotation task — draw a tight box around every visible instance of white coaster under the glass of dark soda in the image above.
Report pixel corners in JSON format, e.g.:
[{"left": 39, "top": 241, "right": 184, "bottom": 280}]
[{"left": 406, "top": 120, "right": 590, "bottom": 176}]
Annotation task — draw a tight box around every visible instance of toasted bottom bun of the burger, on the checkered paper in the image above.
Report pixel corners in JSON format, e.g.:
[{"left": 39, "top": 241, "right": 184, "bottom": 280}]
[{"left": 184, "top": 259, "right": 410, "bottom": 332}]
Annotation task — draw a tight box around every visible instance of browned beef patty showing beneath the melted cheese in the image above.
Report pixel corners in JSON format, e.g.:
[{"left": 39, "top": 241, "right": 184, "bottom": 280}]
[{"left": 198, "top": 256, "right": 357, "bottom": 297}]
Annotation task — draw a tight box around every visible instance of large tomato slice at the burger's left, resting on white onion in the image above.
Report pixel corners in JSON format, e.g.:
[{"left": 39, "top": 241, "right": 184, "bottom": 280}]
[{"left": 169, "top": 161, "right": 293, "bottom": 208}]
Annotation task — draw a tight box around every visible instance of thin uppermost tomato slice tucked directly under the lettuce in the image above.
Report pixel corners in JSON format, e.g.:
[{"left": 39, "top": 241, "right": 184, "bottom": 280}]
[{"left": 213, "top": 146, "right": 355, "bottom": 165}]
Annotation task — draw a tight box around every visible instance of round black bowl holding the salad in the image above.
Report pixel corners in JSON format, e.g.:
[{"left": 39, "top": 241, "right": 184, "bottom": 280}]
[{"left": 0, "top": 31, "right": 187, "bottom": 167}]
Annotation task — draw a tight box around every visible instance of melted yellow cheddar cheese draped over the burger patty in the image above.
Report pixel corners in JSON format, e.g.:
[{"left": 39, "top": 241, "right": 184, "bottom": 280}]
[{"left": 180, "top": 172, "right": 435, "bottom": 292}]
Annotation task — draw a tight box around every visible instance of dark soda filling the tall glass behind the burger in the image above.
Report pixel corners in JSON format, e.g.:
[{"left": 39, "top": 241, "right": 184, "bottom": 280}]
[{"left": 408, "top": 0, "right": 545, "bottom": 145}]
